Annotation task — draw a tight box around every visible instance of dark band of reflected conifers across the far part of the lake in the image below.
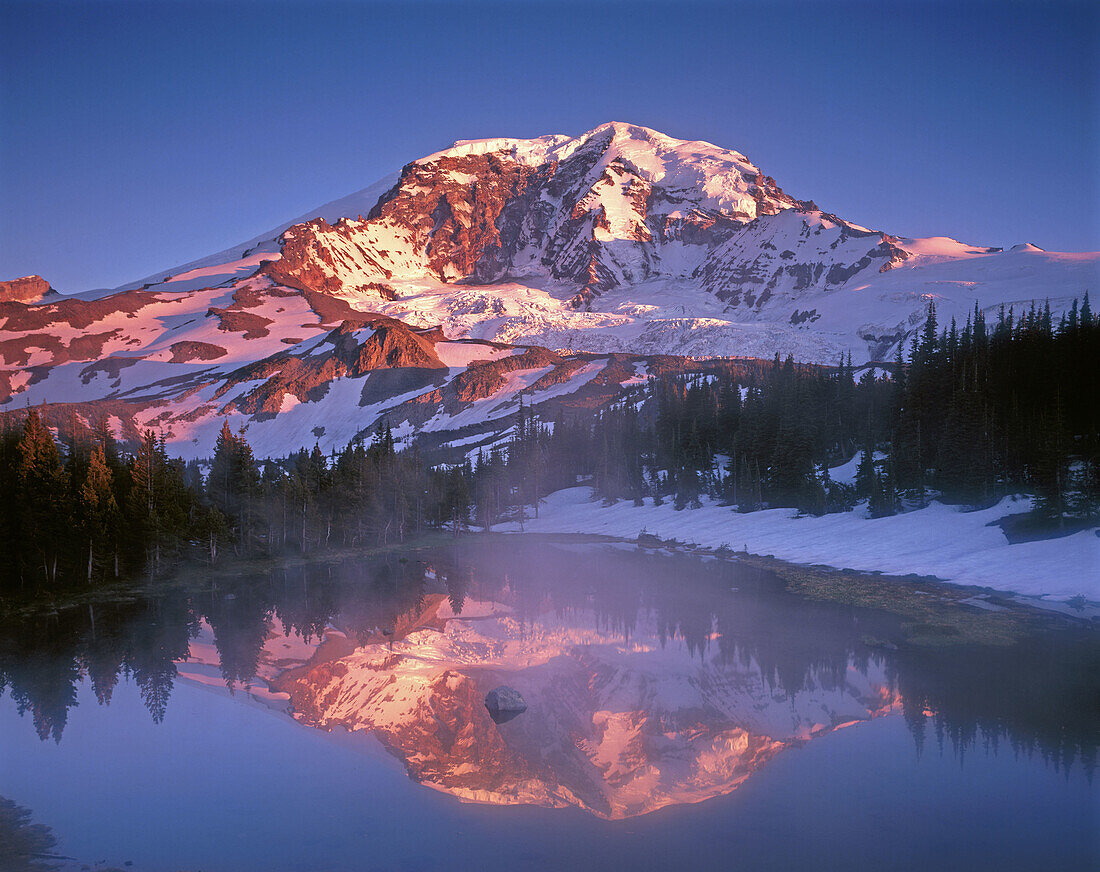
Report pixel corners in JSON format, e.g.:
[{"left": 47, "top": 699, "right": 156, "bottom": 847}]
[{"left": 0, "top": 539, "right": 1100, "bottom": 791}]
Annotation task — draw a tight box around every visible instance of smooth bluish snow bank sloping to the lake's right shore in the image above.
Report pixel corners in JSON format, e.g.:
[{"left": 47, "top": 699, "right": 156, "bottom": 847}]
[{"left": 494, "top": 487, "right": 1100, "bottom": 600}]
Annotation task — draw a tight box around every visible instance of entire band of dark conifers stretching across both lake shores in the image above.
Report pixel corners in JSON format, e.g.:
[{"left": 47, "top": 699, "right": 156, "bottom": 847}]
[{"left": 0, "top": 295, "right": 1100, "bottom": 589}]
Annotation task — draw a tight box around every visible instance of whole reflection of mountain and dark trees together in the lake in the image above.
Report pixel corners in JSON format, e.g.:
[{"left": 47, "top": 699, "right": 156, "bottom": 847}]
[{"left": 0, "top": 539, "right": 1100, "bottom": 818}]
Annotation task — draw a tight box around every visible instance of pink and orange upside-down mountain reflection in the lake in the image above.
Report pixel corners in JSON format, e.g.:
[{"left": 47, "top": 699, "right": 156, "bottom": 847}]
[{"left": 272, "top": 590, "right": 898, "bottom": 818}]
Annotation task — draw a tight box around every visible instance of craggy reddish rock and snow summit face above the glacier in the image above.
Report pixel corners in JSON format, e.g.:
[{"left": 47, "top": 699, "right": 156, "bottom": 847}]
[{"left": 253, "top": 123, "right": 844, "bottom": 306}]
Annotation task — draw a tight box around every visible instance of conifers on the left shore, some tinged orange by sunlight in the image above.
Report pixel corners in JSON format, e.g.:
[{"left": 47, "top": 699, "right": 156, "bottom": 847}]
[{"left": 0, "top": 409, "right": 455, "bottom": 590}]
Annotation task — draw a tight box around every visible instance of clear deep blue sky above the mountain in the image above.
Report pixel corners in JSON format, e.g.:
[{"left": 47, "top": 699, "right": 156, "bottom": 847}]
[{"left": 0, "top": 0, "right": 1100, "bottom": 291}]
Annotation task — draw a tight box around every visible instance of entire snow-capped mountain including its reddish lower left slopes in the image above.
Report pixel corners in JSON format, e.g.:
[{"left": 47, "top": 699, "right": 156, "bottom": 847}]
[{"left": 0, "top": 123, "right": 1100, "bottom": 455}]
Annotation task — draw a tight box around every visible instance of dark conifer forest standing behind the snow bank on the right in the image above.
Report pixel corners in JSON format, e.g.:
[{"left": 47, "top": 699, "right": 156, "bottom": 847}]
[{"left": 454, "top": 295, "right": 1100, "bottom": 526}]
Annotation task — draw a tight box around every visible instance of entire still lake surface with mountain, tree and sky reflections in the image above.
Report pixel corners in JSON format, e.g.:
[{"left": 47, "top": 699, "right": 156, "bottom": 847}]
[{"left": 0, "top": 538, "right": 1100, "bottom": 871}]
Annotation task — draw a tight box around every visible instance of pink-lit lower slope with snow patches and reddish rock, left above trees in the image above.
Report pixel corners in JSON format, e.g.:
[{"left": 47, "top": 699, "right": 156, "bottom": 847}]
[{"left": 0, "top": 268, "right": 678, "bottom": 457}]
